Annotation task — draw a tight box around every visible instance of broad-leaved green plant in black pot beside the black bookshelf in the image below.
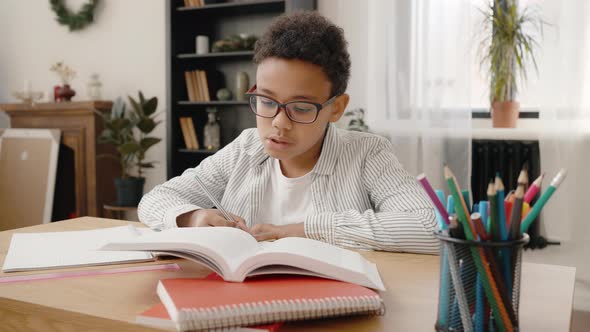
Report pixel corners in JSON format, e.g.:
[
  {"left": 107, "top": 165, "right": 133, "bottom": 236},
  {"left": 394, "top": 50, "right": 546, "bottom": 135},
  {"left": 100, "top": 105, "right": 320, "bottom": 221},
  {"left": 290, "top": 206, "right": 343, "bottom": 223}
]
[{"left": 98, "top": 91, "right": 161, "bottom": 206}]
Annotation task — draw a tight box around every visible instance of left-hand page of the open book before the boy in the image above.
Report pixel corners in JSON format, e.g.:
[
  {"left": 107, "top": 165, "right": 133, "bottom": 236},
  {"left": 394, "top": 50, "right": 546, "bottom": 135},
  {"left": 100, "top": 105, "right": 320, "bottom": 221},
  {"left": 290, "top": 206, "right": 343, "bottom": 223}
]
[{"left": 104, "top": 227, "right": 261, "bottom": 281}]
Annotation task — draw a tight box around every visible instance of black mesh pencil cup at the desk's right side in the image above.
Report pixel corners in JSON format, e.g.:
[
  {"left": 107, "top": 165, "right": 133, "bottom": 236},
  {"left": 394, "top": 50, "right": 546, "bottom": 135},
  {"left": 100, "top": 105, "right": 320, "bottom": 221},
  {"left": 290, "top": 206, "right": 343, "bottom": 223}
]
[{"left": 435, "top": 233, "right": 529, "bottom": 332}]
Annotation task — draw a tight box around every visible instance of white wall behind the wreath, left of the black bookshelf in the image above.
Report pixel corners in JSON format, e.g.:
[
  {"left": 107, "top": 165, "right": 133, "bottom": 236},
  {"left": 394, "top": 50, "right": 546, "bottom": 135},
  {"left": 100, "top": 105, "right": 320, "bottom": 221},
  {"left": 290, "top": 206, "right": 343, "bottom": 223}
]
[{"left": 0, "top": 0, "right": 166, "bottom": 190}]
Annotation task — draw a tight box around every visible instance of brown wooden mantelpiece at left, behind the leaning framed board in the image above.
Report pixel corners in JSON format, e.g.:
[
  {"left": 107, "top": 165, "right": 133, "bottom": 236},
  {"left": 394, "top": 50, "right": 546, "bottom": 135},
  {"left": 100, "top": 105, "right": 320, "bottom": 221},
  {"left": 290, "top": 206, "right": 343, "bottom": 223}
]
[{"left": 0, "top": 101, "right": 120, "bottom": 220}]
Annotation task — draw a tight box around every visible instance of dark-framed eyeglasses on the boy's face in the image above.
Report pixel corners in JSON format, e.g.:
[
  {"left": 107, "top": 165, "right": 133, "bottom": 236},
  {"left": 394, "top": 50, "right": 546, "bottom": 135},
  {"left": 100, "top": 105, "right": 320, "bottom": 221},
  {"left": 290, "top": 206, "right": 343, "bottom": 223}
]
[{"left": 246, "top": 85, "right": 338, "bottom": 124}]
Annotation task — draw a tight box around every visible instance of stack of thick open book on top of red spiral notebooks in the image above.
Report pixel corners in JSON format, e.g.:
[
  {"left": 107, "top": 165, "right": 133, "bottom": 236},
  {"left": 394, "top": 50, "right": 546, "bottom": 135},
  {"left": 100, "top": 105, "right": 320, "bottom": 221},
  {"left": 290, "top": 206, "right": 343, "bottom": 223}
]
[{"left": 102, "top": 227, "right": 384, "bottom": 331}]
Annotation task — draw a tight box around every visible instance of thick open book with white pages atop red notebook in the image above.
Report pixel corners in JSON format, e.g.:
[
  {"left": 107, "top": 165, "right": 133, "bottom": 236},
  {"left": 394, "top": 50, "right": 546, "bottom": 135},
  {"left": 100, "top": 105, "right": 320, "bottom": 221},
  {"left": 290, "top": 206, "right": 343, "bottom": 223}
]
[{"left": 101, "top": 227, "right": 385, "bottom": 290}]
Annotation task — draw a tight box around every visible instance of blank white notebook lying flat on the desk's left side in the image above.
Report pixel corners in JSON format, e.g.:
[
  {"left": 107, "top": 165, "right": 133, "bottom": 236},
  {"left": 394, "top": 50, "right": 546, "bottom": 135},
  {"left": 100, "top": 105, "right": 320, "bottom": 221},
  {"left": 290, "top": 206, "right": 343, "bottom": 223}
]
[{"left": 2, "top": 226, "right": 153, "bottom": 272}]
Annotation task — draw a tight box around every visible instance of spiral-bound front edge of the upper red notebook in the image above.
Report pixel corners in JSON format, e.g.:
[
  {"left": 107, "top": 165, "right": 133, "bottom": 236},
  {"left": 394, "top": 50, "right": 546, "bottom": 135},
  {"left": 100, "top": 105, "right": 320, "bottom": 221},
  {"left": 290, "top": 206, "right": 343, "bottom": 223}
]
[{"left": 177, "top": 295, "right": 385, "bottom": 331}]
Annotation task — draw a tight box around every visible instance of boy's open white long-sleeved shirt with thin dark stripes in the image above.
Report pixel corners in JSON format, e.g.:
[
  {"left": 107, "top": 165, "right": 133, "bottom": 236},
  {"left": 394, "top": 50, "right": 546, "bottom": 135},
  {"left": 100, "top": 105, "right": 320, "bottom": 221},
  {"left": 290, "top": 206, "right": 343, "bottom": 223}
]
[{"left": 138, "top": 124, "right": 439, "bottom": 253}]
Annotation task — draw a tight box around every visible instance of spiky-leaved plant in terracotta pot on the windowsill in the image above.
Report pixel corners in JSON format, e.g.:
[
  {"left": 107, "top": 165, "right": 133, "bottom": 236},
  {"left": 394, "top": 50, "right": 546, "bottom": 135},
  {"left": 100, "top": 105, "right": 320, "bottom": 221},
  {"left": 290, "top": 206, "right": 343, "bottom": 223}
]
[{"left": 480, "top": 0, "right": 544, "bottom": 128}]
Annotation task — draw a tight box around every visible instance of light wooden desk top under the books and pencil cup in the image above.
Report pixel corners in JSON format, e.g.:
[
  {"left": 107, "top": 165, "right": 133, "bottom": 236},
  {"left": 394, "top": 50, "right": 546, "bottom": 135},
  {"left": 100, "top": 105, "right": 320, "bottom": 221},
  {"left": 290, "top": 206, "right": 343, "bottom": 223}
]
[{"left": 0, "top": 217, "right": 575, "bottom": 332}]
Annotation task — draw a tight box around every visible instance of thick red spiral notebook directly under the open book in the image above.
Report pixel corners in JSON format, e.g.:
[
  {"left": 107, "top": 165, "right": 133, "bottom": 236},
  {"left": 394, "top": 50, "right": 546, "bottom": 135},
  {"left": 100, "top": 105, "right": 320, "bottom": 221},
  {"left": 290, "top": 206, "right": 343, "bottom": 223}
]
[{"left": 157, "top": 275, "right": 385, "bottom": 331}]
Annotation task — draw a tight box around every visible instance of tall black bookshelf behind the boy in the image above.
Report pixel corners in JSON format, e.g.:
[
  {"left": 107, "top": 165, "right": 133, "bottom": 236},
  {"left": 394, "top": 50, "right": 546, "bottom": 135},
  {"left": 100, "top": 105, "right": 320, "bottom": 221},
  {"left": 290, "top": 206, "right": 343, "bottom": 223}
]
[{"left": 166, "top": 0, "right": 316, "bottom": 178}]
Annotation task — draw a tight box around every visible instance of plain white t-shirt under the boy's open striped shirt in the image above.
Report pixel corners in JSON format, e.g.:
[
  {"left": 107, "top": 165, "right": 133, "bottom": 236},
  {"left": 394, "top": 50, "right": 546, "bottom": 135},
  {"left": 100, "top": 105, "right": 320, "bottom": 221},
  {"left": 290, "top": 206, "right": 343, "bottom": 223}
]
[{"left": 256, "top": 159, "right": 312, "bottom": 225}]
